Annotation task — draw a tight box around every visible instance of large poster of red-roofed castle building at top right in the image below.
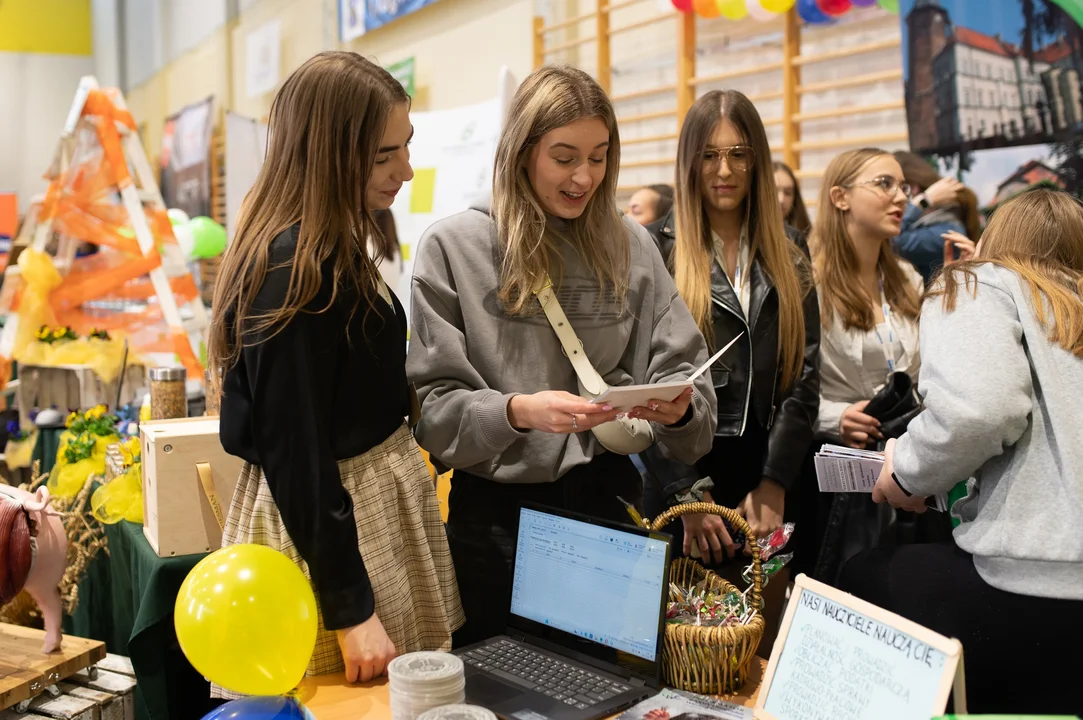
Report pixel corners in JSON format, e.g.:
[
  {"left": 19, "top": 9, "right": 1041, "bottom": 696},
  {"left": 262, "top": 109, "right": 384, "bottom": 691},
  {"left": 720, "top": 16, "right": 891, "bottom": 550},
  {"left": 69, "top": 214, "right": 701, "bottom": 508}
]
[{"left": 899, "top": 0, "right": 1083, "bottom": 217}]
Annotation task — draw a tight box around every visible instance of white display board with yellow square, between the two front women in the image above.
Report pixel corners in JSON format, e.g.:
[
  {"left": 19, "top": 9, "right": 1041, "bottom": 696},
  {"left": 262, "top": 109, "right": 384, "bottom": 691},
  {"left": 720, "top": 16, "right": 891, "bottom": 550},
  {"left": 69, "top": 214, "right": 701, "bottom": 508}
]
[{"left": 391, "top": 67, "right": 517, "bottom": 317}]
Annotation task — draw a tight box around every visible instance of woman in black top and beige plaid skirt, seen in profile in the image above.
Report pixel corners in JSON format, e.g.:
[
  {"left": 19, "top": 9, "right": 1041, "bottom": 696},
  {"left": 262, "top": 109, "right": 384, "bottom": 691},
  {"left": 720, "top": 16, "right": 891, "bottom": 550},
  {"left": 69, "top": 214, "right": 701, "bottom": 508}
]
[{"left": 209, "top": 52, "right": 462, "bottom": 697}]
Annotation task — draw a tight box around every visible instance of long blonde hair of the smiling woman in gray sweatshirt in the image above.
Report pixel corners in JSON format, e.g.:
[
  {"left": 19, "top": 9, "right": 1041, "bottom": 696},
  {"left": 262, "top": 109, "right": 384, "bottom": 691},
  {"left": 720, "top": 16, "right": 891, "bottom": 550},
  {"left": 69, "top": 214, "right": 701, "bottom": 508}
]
[{"left": 493, "top": 65, "right": 630, "bottom": 315}]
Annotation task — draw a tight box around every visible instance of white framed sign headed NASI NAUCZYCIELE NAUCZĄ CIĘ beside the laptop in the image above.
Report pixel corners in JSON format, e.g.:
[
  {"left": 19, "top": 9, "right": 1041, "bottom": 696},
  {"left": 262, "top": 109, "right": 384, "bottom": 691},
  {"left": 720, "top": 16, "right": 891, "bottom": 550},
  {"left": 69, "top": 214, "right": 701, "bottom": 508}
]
[{"left": 755, "top": 575, "right": 966, "bottom": 720}]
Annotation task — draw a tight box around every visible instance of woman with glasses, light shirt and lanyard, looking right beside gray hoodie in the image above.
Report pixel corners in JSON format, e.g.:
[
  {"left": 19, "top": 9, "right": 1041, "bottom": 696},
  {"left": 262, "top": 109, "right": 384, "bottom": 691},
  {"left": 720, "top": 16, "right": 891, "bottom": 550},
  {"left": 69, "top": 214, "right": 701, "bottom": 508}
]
[{"left": 798, "top": 148, "right": 974, "bottom": 582}]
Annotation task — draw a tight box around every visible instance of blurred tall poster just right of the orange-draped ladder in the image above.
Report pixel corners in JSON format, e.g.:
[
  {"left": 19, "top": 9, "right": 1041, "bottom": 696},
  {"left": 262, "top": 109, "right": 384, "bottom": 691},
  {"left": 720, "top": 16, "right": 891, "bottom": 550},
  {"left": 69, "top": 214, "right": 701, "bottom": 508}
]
[{"left": 159, "top": 96, "right": 214, "bottom": 218}]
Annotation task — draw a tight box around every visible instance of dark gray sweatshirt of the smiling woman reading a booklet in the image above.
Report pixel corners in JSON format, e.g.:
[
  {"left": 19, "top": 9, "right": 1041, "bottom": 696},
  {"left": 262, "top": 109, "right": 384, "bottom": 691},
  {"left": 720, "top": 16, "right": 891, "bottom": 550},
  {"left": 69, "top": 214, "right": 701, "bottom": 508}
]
[{"left": 406, "top": 202, "right": 717, "bottom": 483}]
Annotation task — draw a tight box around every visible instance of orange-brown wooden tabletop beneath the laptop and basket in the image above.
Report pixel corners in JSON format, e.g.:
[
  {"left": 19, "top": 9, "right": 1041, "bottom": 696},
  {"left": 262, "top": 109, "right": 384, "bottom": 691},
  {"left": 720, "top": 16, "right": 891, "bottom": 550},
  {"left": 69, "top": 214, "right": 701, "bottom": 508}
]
[{"left": 301, "top": 657, "right": 767, "bottom": 720}]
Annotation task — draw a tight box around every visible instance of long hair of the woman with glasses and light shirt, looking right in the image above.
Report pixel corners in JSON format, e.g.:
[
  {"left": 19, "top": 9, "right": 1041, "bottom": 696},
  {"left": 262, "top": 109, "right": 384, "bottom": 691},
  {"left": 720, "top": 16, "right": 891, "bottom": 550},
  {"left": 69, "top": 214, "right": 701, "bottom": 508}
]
[{"left": 809, "top": 147, "right": 921, "bottom": 332}]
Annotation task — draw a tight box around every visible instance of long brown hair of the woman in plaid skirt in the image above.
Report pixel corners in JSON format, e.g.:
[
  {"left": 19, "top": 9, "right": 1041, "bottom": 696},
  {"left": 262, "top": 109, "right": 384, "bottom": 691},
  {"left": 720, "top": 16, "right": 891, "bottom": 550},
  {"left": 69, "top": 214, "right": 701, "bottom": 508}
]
[{"left": 208, "top": 52, "right": 409, "bottom": 383}]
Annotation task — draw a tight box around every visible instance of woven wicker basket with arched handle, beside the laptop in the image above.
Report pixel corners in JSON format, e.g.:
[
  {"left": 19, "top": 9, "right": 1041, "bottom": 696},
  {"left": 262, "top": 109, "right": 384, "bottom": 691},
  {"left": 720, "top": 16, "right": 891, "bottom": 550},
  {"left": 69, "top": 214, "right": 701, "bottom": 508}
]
[{"left": 651, "top": 502, "right": 764, "bottom": 695}]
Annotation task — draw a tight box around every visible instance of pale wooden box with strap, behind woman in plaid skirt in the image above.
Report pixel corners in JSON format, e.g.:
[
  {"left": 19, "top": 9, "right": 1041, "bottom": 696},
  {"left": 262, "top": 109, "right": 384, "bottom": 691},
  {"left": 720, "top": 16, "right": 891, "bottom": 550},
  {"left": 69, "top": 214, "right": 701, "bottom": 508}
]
[{"left": 140, "top": 417, "right": 244, "bottom": 558}]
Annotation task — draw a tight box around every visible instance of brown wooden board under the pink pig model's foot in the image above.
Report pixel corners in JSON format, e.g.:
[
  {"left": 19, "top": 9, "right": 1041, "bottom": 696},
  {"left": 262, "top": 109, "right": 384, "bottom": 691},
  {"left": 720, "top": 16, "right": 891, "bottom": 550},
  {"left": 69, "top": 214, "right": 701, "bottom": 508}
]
[{"left": 0, "top": 623, "right": 105, "bottom": 709}]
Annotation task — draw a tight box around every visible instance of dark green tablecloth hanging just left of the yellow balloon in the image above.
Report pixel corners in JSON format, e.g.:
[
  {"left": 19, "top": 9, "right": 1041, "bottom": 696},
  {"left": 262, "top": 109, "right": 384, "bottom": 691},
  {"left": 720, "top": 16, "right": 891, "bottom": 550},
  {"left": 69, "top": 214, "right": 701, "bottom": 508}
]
[{"left": 67, "top": 522, "right": 217, "bottom": 720}]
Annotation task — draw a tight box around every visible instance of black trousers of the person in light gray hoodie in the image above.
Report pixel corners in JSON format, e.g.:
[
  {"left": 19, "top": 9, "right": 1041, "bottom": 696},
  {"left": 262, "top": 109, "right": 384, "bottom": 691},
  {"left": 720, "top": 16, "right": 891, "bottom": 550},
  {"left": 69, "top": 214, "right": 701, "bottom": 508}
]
[{"left": 839, "top": 542, "right": 1083, "bottom": 715}]
